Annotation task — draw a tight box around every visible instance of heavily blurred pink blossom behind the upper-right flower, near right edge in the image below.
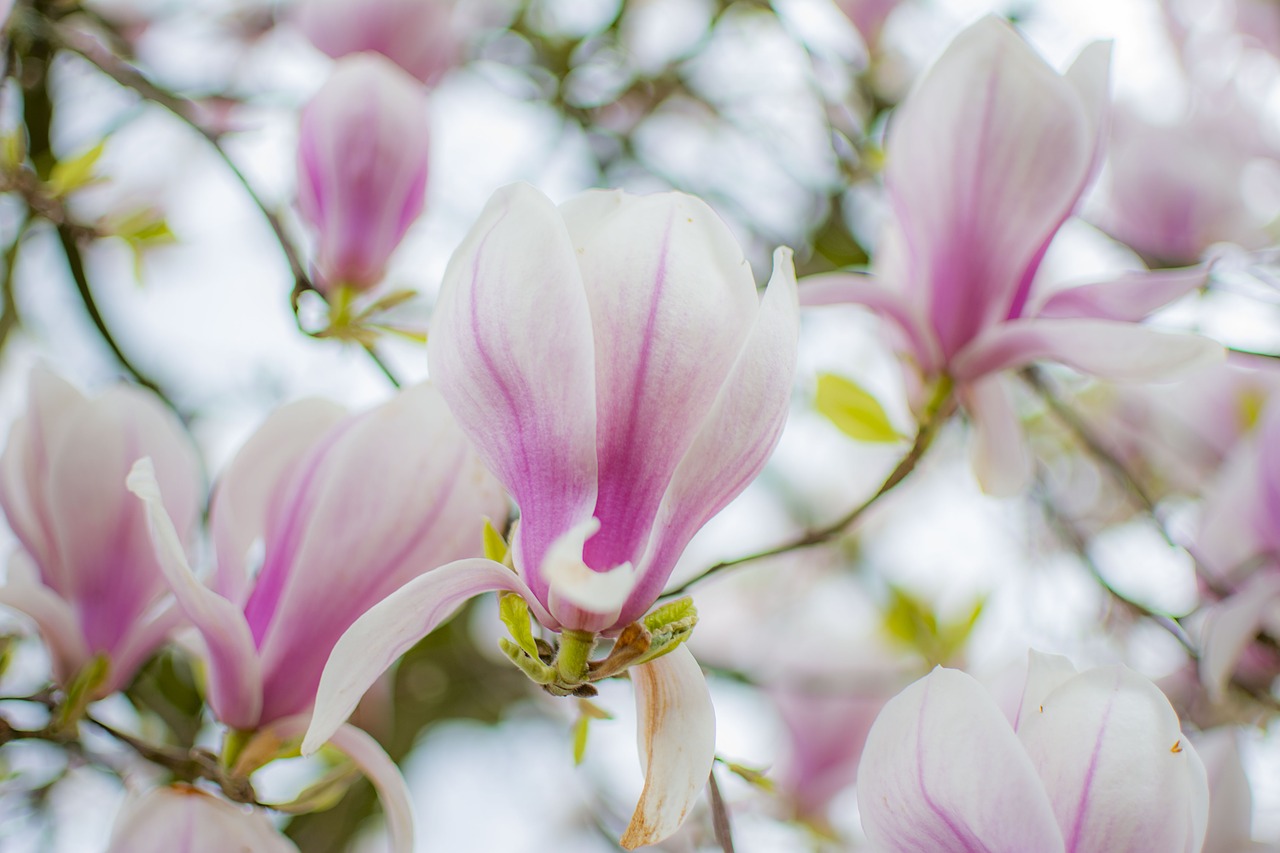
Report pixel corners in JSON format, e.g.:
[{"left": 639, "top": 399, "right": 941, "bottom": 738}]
[{"left": 1094, "top": 96, "right": 1268, "bottom": 265}]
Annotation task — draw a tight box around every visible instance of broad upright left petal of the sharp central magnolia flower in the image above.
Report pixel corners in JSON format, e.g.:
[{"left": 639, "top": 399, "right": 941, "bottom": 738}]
[{"left": 429, "top": 184, "right": 596, "bottom": 601}]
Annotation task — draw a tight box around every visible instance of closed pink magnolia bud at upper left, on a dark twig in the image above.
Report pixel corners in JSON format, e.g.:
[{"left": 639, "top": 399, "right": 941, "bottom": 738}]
[{"left": 298, "top": 54, "right": 428, "bottom": 292}]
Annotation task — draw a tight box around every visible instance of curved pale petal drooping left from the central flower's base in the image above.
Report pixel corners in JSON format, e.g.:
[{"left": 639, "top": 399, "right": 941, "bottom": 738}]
[{"left": 302, "top": 558, "right": 543, "bottom": 754}]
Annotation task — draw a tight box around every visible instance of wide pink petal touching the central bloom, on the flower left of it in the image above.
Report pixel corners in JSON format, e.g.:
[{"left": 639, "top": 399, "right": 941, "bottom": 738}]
[{"left": 244, "top": 384, "right": 507, "bottom": 720}]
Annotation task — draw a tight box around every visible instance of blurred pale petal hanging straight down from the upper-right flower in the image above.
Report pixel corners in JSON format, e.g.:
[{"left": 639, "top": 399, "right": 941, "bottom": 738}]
[{"left": 960, "top": 375, "right": 1032, "bottom": 497}]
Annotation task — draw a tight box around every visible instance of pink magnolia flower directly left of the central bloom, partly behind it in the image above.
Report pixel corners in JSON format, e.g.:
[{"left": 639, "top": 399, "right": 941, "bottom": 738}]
[{"left": 129, "top": 386, "right": 507, "bottom": 845}]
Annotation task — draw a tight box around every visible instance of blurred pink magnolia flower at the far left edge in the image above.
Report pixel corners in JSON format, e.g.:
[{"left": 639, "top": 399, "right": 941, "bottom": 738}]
[{"left": 0, "top": 369, "right": 201, "bottom": 695}]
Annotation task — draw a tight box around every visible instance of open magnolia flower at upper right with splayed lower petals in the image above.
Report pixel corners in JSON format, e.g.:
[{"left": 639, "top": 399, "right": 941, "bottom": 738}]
[{"left": 801, "top": 17, "right": 1222, "bottom": 493}]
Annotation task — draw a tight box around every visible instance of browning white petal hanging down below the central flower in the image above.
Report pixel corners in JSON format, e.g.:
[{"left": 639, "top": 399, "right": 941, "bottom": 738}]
[{"left": 621, "top": 646, "right": 716, "bottom": 850}]
